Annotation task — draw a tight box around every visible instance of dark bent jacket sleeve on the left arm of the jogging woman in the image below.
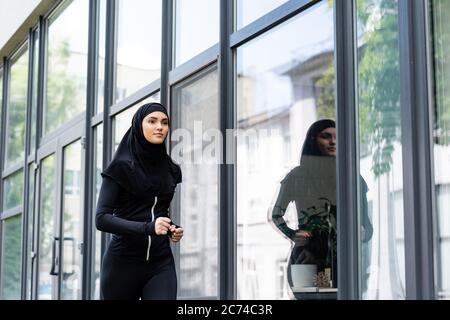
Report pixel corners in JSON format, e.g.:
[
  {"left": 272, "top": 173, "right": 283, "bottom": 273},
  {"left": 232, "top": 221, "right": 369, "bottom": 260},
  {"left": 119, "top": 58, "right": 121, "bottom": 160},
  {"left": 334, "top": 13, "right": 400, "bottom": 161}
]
[{"left": 95, "top": 177, "right": 156, "bottom": 235}]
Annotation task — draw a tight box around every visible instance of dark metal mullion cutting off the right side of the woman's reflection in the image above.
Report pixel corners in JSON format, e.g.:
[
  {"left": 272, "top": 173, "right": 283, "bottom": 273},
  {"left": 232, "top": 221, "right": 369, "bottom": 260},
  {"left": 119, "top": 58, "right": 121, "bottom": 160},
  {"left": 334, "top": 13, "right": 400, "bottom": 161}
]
[{"left": 334, "top": 0, "right": 360, "bottom": 299}]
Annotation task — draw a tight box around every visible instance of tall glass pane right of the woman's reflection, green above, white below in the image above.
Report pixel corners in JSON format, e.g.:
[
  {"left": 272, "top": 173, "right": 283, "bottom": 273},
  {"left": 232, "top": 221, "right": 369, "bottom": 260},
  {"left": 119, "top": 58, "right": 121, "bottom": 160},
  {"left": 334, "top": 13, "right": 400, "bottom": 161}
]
[{"left": 357, "top": 0, "right": 405, "bottom": 300}]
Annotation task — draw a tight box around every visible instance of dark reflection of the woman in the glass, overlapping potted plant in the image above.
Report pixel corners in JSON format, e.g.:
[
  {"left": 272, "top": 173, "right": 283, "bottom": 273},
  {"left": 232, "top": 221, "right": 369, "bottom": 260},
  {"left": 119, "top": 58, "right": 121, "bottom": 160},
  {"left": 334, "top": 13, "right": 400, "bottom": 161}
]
[{"left": 272, "top": 119, "right": 336, "bottom": 287}]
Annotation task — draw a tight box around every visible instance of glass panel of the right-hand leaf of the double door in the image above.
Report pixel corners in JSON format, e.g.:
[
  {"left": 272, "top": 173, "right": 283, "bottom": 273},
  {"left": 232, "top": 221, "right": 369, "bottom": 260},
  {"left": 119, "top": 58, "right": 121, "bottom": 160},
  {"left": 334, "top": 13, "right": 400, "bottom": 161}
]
[{"left": 61, "top": 140, "right": 83, "bottom": 300}]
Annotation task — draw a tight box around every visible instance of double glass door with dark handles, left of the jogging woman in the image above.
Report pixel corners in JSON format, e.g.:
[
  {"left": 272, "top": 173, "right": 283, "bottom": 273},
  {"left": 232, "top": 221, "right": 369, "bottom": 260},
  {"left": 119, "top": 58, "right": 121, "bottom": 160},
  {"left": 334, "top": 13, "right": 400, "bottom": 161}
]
[{"left": 35, "top": 126, "right": 84, "bottom": 300}]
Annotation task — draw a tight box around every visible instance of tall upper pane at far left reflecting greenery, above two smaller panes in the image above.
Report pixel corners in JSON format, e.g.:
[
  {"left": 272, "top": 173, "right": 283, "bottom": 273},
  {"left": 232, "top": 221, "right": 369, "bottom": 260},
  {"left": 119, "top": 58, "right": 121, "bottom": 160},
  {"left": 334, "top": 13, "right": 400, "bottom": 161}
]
[{"left": 5, "top": 50, "right": 28, "bottom": 168}]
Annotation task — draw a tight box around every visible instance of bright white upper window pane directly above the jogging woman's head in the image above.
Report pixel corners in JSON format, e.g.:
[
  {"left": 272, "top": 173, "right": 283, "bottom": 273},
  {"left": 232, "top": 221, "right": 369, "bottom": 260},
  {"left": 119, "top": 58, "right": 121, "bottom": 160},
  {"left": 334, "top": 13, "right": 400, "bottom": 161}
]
[{"left": 115, "top": 0, "right": 162, "bottom": 102}]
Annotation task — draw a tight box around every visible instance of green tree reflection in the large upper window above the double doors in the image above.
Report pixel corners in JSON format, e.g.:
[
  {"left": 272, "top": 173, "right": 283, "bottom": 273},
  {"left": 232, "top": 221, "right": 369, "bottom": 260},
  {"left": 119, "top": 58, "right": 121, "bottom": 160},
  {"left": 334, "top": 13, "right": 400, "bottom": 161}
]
[{"left": 45, "top": 40, "right": 78, "bottom": 132}]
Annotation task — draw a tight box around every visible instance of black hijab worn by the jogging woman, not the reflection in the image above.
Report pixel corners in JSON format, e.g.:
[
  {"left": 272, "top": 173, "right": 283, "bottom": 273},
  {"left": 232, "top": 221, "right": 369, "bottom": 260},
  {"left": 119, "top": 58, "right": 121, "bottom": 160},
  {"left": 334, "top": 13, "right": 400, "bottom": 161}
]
[{"left": 102, "top": 102, "right": 181, "bottom": 196}]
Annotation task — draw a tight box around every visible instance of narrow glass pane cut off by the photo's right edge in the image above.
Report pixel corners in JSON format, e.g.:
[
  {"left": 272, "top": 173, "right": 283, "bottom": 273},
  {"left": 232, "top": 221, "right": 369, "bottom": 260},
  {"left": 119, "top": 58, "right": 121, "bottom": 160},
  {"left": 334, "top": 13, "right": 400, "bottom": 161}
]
[{"left": 431, "top": 0, "right": 450, "bottom": 299}]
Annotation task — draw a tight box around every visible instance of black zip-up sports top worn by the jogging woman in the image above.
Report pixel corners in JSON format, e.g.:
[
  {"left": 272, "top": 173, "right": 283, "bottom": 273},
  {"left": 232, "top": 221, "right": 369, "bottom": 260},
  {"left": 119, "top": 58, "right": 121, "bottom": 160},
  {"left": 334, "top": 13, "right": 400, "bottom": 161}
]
[{"left": 95, "top": 175, "right": 176, "bottom": 261}]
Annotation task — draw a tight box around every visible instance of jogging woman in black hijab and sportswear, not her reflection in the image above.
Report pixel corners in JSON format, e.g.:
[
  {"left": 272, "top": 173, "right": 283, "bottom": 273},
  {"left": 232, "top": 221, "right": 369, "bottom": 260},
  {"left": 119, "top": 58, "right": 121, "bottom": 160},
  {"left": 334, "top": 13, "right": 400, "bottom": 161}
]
[{"left": 96, "top": 103, "right": 183, "bottom": 300}]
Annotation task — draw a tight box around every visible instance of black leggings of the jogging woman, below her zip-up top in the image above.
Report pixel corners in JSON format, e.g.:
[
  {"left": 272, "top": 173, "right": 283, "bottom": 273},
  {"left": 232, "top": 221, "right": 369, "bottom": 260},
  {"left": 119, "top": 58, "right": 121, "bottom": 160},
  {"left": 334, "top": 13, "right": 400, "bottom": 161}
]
[{"left": 100, "top": 250, "right": 177, "bottom": 300}]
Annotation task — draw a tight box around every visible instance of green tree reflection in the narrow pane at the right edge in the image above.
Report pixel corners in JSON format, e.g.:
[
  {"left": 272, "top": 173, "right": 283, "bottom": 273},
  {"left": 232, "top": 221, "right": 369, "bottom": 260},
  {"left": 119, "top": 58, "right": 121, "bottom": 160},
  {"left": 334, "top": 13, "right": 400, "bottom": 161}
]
[{"left": 431, "top": 0, "right": 450, "bottom": 145}]
